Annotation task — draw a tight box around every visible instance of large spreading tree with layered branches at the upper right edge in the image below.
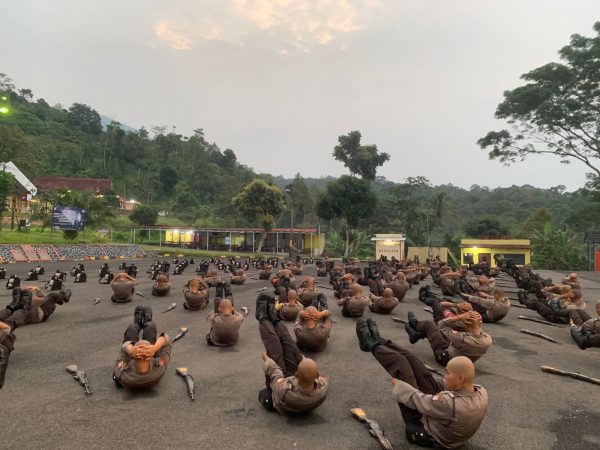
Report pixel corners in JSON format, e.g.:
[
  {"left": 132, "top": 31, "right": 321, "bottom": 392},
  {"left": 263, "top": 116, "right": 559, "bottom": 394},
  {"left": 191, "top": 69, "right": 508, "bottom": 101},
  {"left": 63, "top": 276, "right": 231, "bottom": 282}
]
[{"left": 477, "top": 22, "right": 600, "bottom": 185}]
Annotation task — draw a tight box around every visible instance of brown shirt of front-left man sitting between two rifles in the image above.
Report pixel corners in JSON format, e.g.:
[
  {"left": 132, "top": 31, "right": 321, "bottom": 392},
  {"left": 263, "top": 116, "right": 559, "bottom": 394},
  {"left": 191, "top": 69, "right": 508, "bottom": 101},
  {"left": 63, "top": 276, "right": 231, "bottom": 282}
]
[{"left": 113, "top": 336, "right": 171, "bottom": 391}]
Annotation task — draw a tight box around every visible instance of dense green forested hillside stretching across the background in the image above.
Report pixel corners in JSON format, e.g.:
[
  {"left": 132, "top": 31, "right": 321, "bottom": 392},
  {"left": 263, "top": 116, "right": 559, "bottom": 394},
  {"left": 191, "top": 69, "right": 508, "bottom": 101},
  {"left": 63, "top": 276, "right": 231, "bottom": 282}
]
[{"left": 0, "top": 75, "right": 600, "bottom": 264}]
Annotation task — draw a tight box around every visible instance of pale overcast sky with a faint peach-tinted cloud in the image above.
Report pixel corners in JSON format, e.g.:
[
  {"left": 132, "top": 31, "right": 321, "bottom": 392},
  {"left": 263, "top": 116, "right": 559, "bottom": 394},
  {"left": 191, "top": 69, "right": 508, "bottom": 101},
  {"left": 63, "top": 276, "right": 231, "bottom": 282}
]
[{"left": 0, "top": 0, "right": 600, "bottom": 190}]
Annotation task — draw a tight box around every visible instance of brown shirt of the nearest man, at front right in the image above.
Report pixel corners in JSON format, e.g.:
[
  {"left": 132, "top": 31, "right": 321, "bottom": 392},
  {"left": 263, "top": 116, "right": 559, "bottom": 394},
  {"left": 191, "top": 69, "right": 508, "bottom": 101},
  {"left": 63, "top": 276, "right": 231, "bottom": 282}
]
[{"left": 393, "top": 380, "right": 488, "bottom": 448}]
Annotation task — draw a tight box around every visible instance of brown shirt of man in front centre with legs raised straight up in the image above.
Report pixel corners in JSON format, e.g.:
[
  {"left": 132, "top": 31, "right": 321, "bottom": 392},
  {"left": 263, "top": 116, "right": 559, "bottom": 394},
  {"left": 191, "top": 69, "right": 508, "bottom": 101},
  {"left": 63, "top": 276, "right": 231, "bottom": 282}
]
[{"left": 264, "top": 358, "right": 329, "bottom": 416}]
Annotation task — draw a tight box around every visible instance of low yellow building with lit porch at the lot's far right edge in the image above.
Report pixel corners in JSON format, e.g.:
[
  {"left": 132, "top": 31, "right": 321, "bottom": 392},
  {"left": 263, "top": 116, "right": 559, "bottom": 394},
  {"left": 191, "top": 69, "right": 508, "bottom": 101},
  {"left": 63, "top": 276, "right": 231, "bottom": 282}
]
[{"left": 460, "top": 239, "right": 531, "bottom": 266}]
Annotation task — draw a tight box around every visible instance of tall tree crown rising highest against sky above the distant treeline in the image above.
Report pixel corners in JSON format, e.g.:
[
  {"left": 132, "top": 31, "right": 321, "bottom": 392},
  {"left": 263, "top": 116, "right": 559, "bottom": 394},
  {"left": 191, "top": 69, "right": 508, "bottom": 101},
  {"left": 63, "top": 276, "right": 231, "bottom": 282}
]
[{"left": 333, "top": 131, "right": 390, "bottom": 181}]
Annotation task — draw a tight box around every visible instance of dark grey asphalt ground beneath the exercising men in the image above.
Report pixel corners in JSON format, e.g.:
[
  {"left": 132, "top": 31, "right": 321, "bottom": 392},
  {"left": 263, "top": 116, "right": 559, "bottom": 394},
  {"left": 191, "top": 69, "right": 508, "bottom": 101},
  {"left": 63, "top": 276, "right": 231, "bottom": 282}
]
[{"left": 0, "top": 259, "right": 600, "bottom": 450}]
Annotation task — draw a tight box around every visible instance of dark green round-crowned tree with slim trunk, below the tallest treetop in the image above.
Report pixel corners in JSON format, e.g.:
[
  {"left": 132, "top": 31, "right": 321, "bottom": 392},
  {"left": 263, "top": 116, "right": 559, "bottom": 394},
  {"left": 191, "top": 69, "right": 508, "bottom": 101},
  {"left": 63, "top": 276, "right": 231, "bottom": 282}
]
[{"left": 317, "top": 175, "right": 377, "bottom": 256}]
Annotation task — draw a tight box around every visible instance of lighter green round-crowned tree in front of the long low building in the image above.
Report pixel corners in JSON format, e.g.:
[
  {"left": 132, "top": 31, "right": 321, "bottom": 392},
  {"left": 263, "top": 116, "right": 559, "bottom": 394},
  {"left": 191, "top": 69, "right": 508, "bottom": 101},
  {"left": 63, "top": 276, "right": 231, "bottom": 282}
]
[{"left": 232, "top": 178, "right": 285, "bottom": 253}]
